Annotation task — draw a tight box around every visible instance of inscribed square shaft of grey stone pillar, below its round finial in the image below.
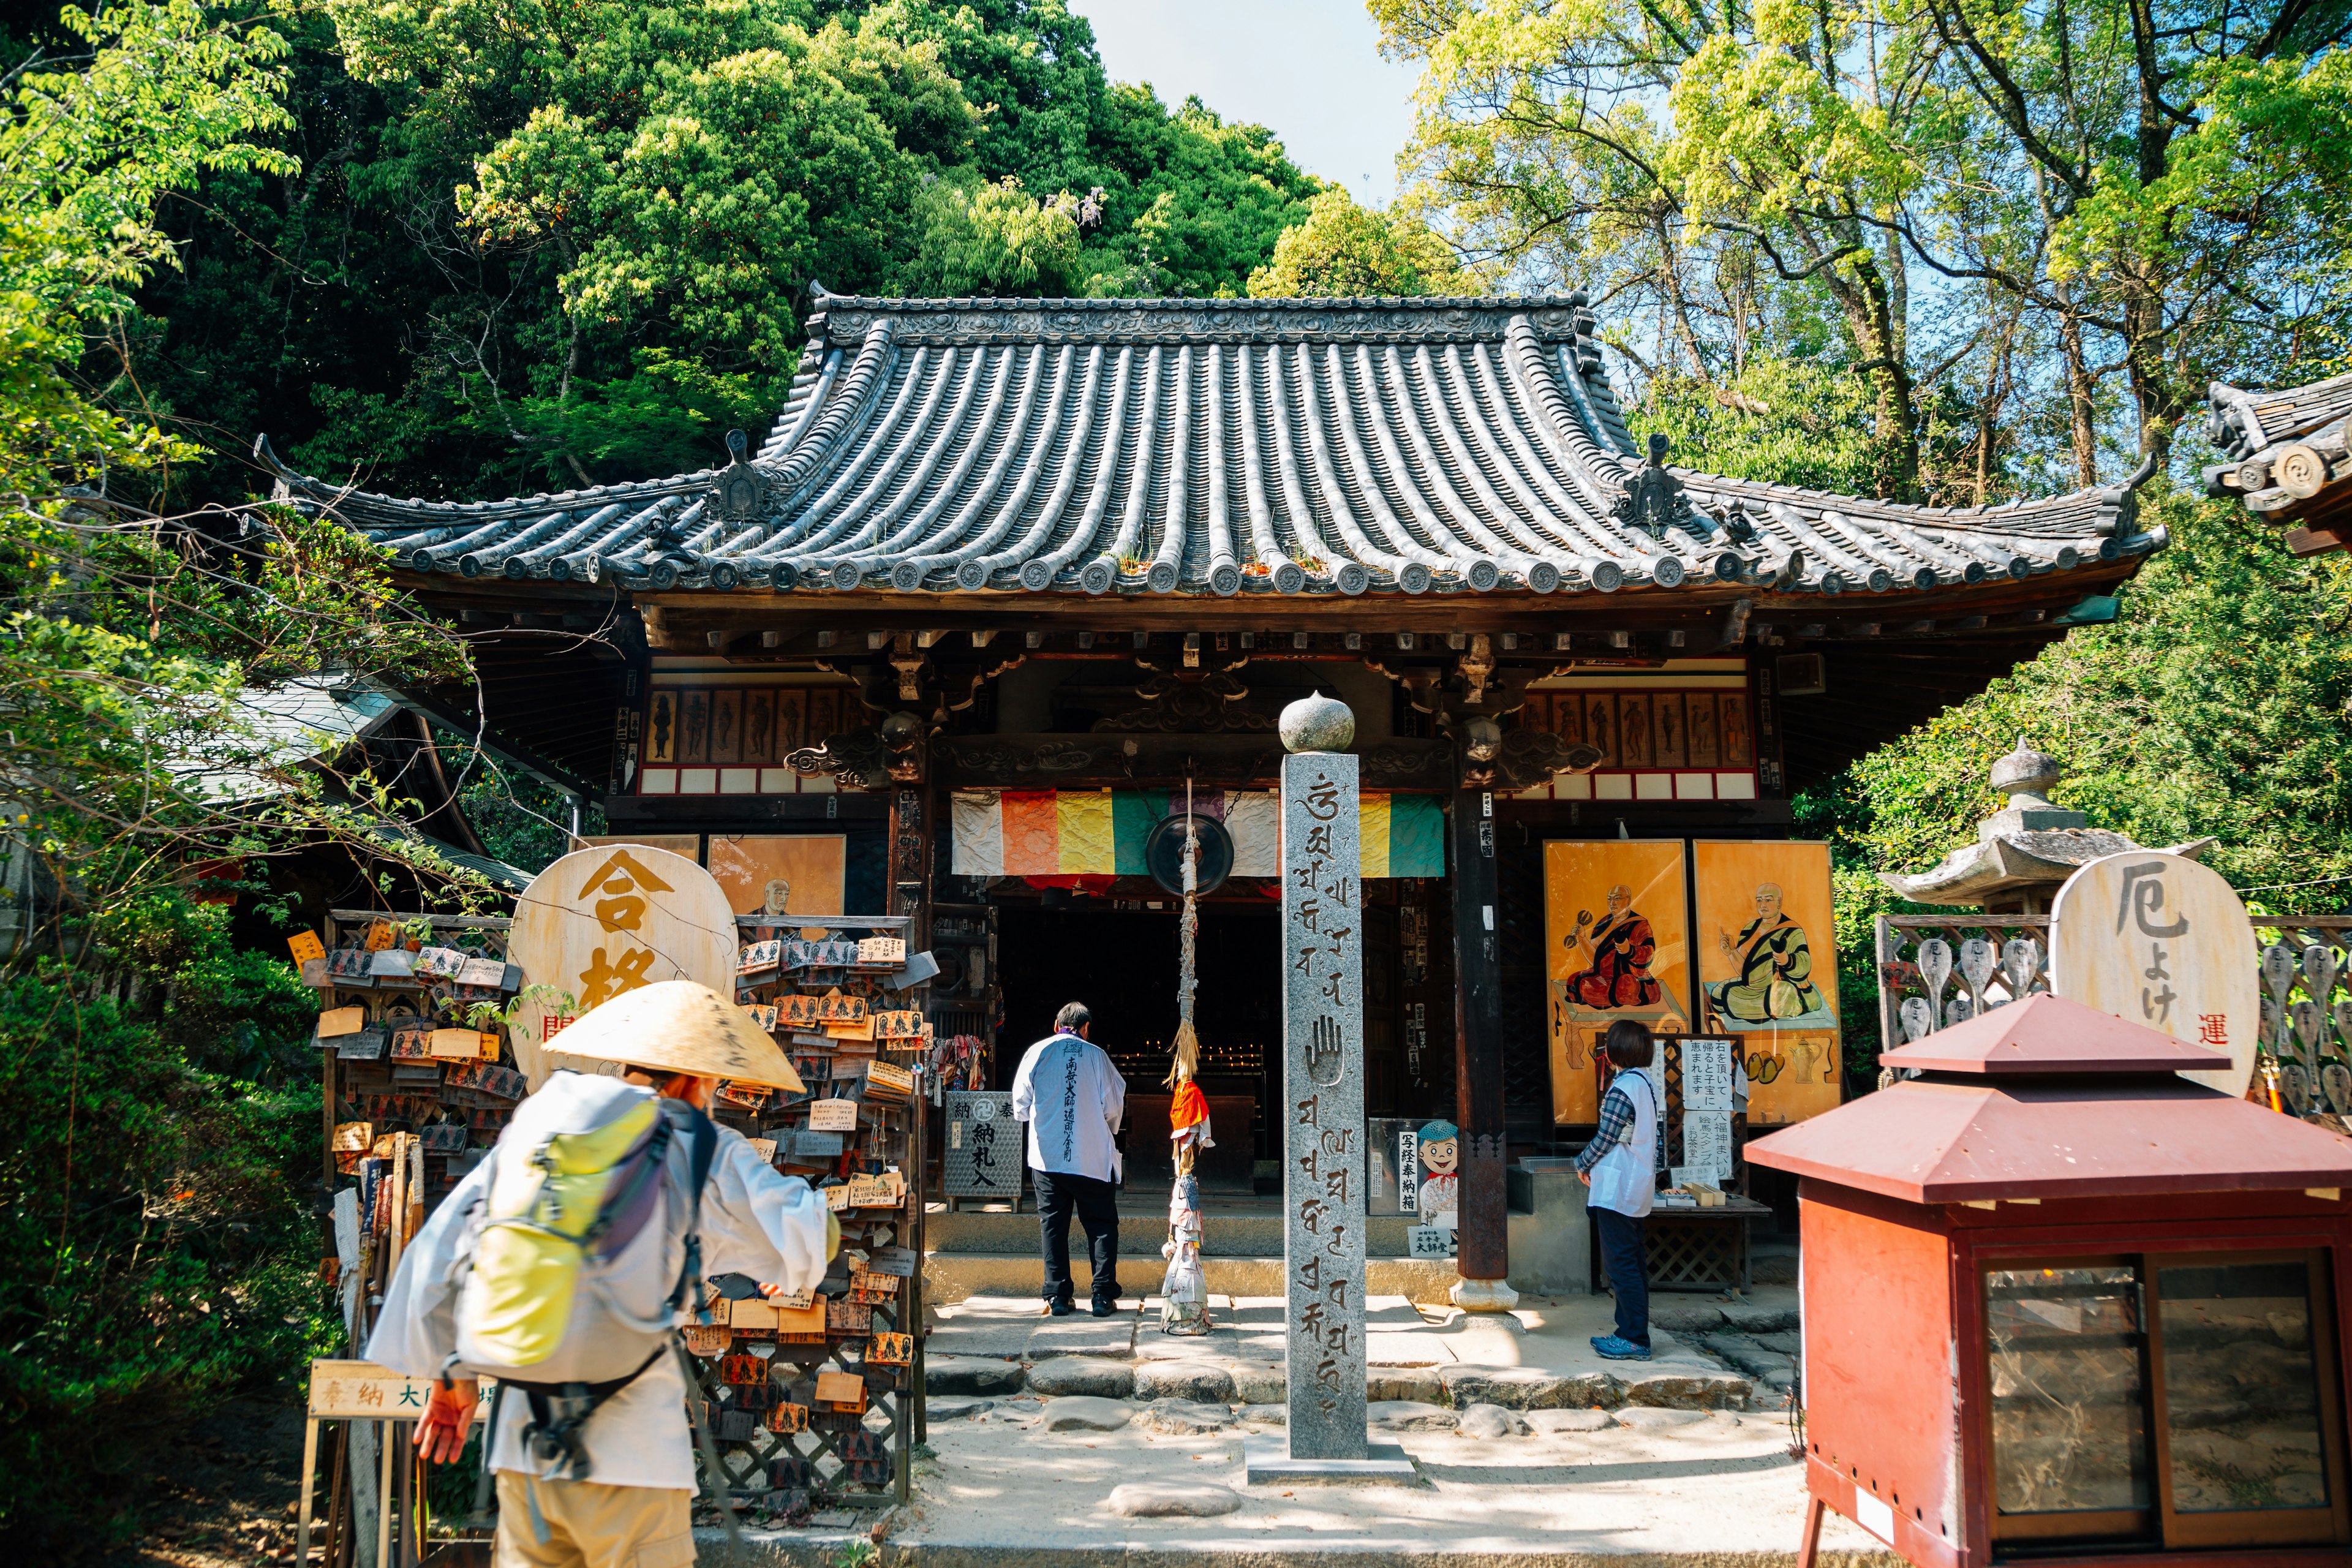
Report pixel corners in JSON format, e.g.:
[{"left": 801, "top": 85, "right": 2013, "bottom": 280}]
[{"left": 1282, "top": 752, "right": 1369, "bottom": 1460}]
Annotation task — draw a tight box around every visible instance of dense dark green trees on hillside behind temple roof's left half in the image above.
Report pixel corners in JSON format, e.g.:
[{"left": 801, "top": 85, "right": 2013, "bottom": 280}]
[{"left": 101, "top": 0, "right": 1317, "bottom": 503}]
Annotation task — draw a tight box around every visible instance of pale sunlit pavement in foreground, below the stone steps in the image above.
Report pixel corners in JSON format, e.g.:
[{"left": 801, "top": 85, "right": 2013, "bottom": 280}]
[{"left": 698, "top": 1394, "right": 1898, "bottom": 1568}]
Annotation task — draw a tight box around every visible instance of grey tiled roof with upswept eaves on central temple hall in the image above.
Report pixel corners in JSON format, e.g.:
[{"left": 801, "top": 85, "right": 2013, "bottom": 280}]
[{"left": 257, "top": 294, "right": 2162, "bottom": 595}]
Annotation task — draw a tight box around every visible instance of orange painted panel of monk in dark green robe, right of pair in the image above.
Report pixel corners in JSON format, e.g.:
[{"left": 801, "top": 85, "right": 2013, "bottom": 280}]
[{"left": 1691, "top": 839, "right": 1844, "bottom": 1128}]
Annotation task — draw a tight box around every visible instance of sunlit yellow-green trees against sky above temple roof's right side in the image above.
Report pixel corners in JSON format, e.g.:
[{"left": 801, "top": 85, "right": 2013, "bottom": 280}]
[{"left": 1374, "top": 0, "right": 2352, "bottom": 501}]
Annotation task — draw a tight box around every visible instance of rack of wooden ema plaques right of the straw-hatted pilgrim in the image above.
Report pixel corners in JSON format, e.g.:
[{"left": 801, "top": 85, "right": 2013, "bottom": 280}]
[{"left": 687, "top": 914, "right": 932, "bottom": 1523}]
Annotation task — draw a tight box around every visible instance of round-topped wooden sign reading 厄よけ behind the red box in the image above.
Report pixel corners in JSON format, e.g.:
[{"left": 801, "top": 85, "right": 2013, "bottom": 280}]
[{"left": 2051, "top": 849, "right": 2263, "bottom": 1096}]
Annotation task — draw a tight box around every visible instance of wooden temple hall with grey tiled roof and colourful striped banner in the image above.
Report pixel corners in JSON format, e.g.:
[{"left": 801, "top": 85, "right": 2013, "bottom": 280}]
[{"left": 263, "top": 292, "right": 2164, "bottom": 1279}]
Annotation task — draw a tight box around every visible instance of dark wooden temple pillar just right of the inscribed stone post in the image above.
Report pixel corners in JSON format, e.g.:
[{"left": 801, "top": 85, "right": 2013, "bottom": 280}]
[{"left": 1453, "top": 790, "right": 1517, "bottom": 1312}]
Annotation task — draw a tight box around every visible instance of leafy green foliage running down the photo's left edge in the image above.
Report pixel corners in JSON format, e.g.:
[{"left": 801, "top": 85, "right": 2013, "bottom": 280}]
[{"left": 0, "top": 0, "right": 486, "bottom": 1561}]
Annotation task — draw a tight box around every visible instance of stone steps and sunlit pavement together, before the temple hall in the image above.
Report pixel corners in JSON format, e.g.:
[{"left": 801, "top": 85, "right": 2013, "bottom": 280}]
[{"left": 696, "top": 1286, "right": 1898, "bottom": 1568}]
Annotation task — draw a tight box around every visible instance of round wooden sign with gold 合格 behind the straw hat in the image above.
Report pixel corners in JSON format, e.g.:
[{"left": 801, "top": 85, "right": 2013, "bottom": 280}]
[{"left": 506, "top": 844, "right": 736, "bottom": 1088}]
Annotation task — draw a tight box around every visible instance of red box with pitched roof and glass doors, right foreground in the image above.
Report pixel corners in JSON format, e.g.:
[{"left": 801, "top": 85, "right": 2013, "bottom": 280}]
[{"left": 1747, "top": 997, "right": 2352, "bottom": 1568}]
